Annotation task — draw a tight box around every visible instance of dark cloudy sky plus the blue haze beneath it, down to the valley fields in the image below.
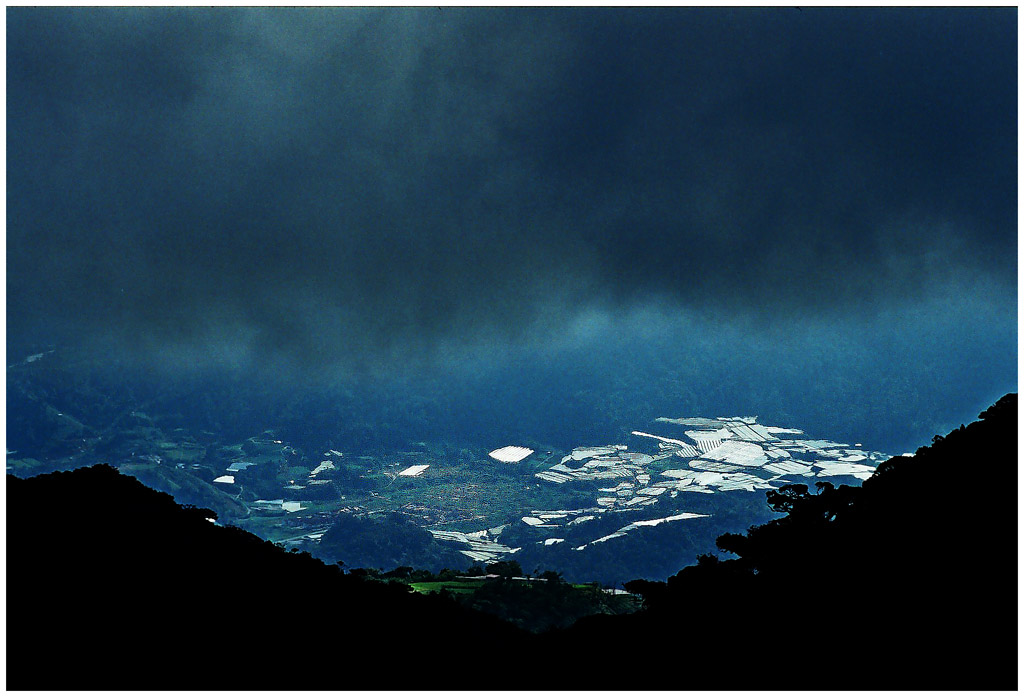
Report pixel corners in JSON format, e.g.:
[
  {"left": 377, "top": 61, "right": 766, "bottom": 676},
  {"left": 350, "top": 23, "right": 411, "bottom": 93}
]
[{"left": 6, "top": 7, "right": 1017, "bottom": 456}]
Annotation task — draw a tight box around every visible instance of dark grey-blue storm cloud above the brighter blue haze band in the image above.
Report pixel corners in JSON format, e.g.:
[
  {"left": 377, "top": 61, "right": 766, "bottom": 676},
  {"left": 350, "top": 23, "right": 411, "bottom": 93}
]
[{"left": 7, "top": 7, "right": 1017, "bottom": 362}]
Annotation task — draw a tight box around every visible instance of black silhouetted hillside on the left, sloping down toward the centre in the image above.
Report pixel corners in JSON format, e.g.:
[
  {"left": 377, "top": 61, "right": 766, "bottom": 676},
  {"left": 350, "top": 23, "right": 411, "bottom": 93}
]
[{"left": 7, "top": 466, "right": 536, "bottom": 690}]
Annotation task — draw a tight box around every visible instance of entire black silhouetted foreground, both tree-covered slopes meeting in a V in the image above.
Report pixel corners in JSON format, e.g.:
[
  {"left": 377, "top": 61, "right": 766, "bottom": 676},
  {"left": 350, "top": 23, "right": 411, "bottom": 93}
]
[{"left": 7, "top": 395, "right": 1017, "bottom": 690}]
